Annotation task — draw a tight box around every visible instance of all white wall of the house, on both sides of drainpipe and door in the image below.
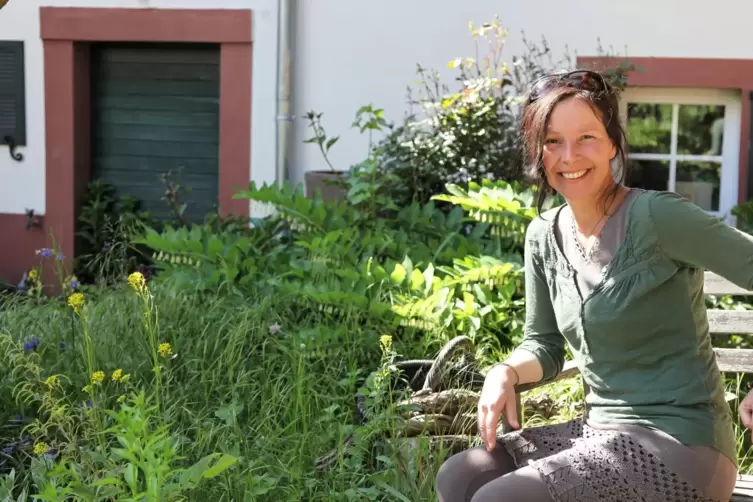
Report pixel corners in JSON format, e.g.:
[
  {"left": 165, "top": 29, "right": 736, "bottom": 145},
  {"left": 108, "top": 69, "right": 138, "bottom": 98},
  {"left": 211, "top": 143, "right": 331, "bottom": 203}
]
[{"left": 0, "top": 0, "right": 753, "bottom": 219}]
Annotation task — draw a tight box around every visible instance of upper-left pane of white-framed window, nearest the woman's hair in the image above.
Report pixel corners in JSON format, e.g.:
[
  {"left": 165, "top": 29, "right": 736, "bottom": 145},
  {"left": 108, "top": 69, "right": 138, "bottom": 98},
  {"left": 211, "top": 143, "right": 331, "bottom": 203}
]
[{"left": 627, "top": 103, "right": 672, "bottom": 153}]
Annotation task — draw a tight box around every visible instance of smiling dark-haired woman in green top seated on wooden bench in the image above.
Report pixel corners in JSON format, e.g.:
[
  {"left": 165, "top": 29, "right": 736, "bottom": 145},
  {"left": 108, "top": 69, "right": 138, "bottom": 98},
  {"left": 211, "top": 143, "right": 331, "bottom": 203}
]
[{"left": 437, "top": 70, "right": 753, "bottom": 502}]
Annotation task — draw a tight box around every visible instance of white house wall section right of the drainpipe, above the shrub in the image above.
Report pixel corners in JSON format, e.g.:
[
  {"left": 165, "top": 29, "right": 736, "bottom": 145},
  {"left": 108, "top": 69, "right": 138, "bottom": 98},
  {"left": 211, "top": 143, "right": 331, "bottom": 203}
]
[{"left": 293, "top": 0, "right": 753, "bottom": 187}]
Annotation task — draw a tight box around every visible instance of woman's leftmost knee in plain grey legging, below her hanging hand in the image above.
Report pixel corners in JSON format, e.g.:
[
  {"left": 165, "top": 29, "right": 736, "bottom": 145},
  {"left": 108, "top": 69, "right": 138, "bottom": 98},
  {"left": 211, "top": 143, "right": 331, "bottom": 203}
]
[{"left": 436, "top": 447, "right": 515, "bottom": 502}]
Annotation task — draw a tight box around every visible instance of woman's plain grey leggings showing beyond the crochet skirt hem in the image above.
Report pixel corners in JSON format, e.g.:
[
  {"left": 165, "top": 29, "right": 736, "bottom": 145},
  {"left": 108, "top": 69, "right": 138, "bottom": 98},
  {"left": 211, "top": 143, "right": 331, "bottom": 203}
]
[{"left": 437, "top": 444, "right": 552, "bottom": 502}]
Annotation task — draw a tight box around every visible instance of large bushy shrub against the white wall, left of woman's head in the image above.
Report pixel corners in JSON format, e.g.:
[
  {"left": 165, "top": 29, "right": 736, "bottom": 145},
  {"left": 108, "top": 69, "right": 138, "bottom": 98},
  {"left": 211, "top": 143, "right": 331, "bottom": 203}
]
[{"left": 364, "top": 18, "right": 637, "bottom": 206}]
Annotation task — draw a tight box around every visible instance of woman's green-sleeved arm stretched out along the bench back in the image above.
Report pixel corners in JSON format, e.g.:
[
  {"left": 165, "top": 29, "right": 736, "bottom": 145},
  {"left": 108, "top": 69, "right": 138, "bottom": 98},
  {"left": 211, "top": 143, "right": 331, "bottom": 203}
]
[{"left": 650, "top": 192, "right": 753, "bottom": 289}]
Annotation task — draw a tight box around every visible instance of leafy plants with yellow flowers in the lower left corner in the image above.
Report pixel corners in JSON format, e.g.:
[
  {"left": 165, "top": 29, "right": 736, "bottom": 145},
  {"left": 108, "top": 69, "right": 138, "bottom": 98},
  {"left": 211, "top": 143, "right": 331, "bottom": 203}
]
[{"left": 0, "top": 272, "right": 237, "bottom": 502}]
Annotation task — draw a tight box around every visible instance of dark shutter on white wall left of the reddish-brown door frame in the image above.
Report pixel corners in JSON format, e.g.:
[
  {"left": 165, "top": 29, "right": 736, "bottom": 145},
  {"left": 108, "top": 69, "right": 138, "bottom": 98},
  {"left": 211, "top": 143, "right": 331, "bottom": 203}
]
[{"left": 0, "top": 41, "right": 26, "bottom": 145}]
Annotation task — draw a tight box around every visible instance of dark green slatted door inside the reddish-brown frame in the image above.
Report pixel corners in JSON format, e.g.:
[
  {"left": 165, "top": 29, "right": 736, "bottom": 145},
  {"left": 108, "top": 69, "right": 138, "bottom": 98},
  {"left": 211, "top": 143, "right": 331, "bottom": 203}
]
[{"left": 91, "top": 44, "right": 220, "bottom": 222}]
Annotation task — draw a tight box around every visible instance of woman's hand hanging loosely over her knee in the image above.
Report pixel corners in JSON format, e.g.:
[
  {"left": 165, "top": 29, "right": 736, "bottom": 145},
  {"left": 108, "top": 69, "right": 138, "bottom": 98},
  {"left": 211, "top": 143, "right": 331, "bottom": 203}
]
[{"left": 478, "top": 365, "right": 520, "bottom": 451}]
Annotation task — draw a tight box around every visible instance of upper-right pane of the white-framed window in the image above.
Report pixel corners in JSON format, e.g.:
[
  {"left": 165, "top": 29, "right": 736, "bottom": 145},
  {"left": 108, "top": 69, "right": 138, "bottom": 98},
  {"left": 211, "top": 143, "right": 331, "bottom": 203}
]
[{"left": 677, "top": 105, "right": 724, "bottom": 155}]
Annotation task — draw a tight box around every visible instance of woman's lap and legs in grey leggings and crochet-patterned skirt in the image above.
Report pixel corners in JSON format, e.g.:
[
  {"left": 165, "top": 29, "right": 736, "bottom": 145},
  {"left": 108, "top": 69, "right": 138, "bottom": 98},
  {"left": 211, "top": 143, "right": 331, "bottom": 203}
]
[{"left": 436, "top": 420, "right": 737, "bottom": 502}]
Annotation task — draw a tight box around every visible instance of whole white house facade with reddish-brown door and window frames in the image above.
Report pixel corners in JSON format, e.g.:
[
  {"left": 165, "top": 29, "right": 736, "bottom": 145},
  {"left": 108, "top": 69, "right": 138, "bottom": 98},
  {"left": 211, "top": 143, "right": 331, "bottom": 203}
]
[{"left": 0, "top": 0, "right": 753, "bottom": 284}]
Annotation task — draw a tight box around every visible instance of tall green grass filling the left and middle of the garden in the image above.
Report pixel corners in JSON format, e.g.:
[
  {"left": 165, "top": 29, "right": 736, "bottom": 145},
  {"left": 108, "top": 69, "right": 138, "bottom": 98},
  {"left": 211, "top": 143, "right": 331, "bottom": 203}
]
[{"left": 0, "top": 284, "right": 458, "bottom": 501}]
